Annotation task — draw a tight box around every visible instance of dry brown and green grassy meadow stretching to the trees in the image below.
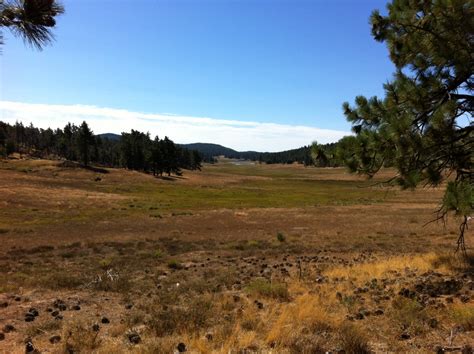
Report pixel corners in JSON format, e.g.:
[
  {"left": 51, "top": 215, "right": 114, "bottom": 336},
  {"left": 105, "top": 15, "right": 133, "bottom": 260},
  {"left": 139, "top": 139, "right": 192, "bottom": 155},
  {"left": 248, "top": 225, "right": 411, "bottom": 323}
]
[{"left": 0, "top": 160, "right": 474, "bottom": 353}]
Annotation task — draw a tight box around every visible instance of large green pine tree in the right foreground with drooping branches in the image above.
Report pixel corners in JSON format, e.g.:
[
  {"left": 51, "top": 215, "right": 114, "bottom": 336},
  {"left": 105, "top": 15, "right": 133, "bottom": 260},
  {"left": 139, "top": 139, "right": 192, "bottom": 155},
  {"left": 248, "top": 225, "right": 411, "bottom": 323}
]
[{"left": 343, "top": 0, "right": 474, "bottom": 251}]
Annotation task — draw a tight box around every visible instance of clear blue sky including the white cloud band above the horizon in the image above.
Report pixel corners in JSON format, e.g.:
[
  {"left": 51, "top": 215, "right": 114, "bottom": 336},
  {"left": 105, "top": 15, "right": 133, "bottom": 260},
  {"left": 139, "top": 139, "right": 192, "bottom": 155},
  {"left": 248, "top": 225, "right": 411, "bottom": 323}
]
[{"left": 0, "top": 0, "right": 393, "bottom": 151}]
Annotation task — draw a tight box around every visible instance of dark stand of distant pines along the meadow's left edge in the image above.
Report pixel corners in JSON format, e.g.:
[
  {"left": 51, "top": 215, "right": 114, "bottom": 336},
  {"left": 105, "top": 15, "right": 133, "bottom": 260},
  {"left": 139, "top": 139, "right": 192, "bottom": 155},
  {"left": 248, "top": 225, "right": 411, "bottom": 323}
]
[{"left": 0, "top": 121, "right": 202, "bottom": 176}]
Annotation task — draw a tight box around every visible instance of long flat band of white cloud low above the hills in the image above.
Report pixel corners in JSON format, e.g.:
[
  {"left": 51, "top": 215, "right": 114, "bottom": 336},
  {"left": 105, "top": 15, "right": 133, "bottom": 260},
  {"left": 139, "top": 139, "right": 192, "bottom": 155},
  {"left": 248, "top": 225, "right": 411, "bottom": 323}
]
[{"left": 0, "top": 101, "right": 349, "bottom": 151}]
